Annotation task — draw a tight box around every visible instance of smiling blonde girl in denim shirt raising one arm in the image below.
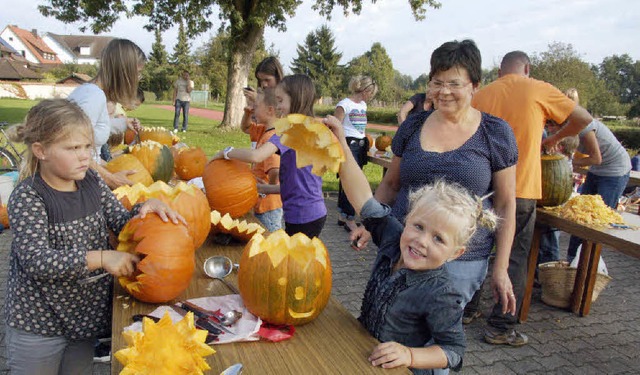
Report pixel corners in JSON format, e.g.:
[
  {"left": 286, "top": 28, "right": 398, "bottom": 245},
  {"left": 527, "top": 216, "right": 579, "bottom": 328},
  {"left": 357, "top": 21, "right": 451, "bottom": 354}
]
[{"left": 324, "top": 116, "right": 498, "bottom": 374}]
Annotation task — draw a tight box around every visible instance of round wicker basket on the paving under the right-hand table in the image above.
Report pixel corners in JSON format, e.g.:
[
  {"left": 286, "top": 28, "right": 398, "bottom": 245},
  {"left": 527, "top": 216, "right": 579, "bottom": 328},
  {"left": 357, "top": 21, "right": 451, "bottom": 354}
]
[{"left": 538, "top": 261, "right": 612, "bottom": 309}]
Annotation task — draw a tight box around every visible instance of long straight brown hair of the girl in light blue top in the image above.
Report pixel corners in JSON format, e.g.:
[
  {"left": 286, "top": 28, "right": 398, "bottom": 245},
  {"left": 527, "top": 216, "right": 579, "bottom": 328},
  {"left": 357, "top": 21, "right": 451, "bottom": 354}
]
[{"left": 96, "top": 39, "right": 146, "bottom": 108}]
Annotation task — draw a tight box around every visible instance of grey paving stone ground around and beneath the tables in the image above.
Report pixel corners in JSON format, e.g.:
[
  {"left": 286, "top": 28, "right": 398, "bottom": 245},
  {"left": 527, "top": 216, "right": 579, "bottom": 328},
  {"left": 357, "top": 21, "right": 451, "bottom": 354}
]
[{"left": 0, "top": 196, "right": 640, "bottom": 375}]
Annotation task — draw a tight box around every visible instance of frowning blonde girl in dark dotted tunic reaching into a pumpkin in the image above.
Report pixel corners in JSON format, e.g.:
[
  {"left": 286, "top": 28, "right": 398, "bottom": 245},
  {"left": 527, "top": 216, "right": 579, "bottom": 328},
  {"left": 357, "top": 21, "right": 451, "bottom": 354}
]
[{"left": 4, "top": 99, "right": 184, "bottom": 375}]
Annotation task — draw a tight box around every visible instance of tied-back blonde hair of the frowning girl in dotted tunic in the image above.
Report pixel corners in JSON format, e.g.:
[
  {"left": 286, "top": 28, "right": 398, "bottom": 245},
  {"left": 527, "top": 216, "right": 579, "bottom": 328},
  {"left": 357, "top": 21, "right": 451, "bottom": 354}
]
[{"left": 7, "top": 99, "right": 93, "bottom": 180}]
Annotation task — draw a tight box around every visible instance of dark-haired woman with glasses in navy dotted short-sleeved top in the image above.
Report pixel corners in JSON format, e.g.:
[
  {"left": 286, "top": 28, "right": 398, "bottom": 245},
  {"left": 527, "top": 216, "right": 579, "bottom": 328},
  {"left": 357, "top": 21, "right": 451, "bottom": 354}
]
[{"left": 352, "top": 40, "right": 518, "bottom": 326}]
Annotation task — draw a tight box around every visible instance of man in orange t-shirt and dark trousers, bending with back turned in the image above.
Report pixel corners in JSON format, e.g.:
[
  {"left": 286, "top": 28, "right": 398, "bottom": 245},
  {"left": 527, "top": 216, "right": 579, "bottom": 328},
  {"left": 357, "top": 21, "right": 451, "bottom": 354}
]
[{"left": 470, "top": 51, "right": 593, "bottom": 346}]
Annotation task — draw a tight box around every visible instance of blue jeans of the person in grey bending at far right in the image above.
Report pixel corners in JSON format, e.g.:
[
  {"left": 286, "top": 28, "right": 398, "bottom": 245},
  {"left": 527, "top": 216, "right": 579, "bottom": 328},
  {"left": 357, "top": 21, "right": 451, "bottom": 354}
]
[{"left": 567, "top": 172, "right": 629, "bottom": 262}]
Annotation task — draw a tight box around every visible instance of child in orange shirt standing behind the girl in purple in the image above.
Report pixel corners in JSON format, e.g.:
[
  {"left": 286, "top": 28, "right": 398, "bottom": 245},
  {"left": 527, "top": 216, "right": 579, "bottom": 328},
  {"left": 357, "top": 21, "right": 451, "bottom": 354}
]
[{"left": 242, "top": 88, "right": 283, "bottom": 232}]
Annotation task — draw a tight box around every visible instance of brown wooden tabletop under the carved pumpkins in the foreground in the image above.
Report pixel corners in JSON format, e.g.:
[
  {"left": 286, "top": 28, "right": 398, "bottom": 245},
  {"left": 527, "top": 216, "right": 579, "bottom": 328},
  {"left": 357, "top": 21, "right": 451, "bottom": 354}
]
[{"left": 111, "top": 239, "right": 410, "bottom": 374}]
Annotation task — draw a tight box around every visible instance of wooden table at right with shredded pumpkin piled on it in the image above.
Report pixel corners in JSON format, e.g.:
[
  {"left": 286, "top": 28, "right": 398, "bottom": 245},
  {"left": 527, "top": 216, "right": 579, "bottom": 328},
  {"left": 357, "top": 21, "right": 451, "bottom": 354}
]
[{"left": 519, "top": 208, "right": 640, "bottom": 322}]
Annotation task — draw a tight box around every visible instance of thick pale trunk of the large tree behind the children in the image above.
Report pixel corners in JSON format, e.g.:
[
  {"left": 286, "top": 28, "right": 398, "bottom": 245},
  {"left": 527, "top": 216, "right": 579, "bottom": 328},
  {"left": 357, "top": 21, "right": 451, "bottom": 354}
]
[{"left": 220, "top": 26, "right": 264, "bottom": 129}]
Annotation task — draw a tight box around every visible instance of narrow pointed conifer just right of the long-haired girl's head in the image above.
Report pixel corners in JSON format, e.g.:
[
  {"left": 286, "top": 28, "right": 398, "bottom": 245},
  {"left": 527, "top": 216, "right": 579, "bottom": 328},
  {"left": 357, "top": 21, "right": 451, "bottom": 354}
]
[{"left": 140, "top": 29, "right": 171, "bottom": 100}]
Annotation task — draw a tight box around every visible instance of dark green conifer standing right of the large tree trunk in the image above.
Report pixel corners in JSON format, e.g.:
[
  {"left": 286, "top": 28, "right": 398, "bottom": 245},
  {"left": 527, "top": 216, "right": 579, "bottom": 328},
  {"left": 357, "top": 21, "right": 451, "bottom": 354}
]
[{"left": 291, "top": 25, "right": 342, "bottom": 97}]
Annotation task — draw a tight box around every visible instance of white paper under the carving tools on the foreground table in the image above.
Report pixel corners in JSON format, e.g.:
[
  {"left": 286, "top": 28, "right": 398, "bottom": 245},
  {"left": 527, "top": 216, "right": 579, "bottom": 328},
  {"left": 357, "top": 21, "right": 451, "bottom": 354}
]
[{"left": 124, "top": 294, "right": 262, "bottom": 344}]
